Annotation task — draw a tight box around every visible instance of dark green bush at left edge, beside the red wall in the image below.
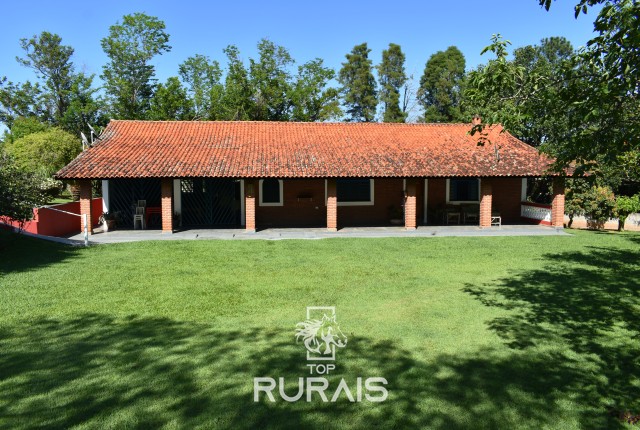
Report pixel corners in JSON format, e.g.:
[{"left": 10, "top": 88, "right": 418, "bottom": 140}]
[{"left": 0, "top": 153, "right": 46, "bottom": 221}]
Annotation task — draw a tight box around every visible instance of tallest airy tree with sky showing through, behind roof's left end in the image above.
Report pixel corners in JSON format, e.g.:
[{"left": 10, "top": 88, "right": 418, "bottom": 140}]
[{"left": 101, "top": 13, "right": 171, "bottom": 119}]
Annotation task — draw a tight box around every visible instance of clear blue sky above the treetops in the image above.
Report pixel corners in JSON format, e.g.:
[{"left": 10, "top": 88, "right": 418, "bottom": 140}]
[{"left": 0, "top": 0, "right": 596, "bottom": 98}]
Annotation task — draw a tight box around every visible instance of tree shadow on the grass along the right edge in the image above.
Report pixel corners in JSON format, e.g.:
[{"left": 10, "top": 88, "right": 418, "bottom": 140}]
[{"left": 466, "top": 244, "right": 640, "bottom": 428}]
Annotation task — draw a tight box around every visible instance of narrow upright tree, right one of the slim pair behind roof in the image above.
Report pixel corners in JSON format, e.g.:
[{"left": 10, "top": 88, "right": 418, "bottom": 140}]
[{"left": 378, "top": 43, "right": 407, "bottom": 122}]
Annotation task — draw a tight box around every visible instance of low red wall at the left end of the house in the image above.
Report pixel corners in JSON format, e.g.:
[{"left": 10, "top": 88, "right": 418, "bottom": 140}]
[{"left": 1, "top": 198, "right": 102, "bottom": 237}]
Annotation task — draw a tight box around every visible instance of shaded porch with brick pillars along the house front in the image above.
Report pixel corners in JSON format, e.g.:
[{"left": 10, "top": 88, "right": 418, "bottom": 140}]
[{"left": 79, "top": 177, "right": 564, "bottom": 233}]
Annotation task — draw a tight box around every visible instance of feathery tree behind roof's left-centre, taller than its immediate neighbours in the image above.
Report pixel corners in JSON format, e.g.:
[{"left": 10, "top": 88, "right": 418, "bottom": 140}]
[{"left": 249, "top": 39, "right": 294, "bottom": 121}]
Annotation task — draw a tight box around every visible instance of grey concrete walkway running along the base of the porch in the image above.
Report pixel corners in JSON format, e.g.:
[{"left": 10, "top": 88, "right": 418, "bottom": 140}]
[{"left": 62, "top": 225, "right": 569, "bottom": 243}]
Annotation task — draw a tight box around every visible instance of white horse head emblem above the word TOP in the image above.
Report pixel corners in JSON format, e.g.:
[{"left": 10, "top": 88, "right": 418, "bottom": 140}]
[{"left": 296, "top": 314, "right": 347, "bottom": 360}]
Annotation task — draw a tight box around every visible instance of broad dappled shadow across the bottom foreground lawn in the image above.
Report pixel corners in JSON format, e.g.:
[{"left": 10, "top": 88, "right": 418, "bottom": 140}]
[{"left": 0, "top": 315, "right": 631, "bottom": 429}]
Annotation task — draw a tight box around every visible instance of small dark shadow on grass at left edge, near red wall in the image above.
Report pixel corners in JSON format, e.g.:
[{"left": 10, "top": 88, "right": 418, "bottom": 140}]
[{"left": 0, "top": 230, "right": 78, "bottom": 276}]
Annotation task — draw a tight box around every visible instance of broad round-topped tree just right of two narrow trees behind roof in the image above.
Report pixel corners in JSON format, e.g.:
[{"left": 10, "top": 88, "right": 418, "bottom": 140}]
[{"left": 418, "top": 46, "right": 465, "bottom": 122}]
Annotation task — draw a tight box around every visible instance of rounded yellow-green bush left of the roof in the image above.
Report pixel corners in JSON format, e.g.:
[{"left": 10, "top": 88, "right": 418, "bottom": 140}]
[{"left": 5, "top": 127, "right": 82, "bottom": 176}]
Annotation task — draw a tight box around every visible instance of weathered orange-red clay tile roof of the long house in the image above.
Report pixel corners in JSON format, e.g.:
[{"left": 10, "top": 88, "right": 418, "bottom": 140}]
[{"left": 57, "top": 120, "right": 551, "bottom": 179}]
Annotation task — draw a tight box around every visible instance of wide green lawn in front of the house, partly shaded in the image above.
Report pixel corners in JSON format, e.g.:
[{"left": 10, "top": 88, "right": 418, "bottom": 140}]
[{"left": 0, "top": 232, "right": 640, "bottom": 429}]
